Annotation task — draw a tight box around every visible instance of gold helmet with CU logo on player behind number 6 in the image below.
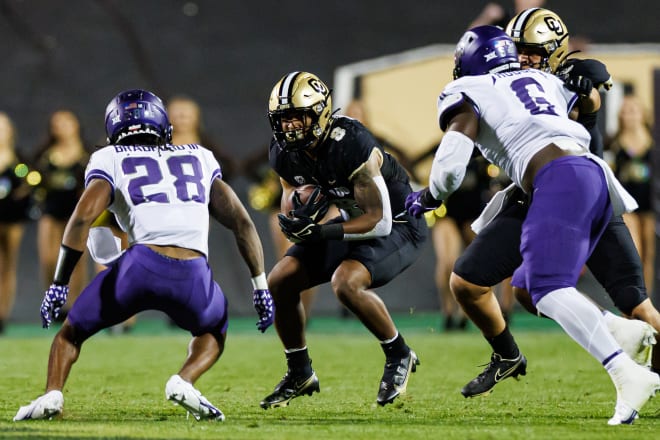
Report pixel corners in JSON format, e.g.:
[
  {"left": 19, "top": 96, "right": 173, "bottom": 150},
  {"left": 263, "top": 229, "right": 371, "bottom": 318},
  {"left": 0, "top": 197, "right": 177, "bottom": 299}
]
[{"left": 506, "top": 8, "right": 569, "bottom": 73}]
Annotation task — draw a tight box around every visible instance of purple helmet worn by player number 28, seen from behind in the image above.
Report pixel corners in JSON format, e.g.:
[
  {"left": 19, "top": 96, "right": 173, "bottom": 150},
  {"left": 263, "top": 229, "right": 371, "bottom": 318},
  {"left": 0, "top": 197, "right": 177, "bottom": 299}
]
[{"left": 105, "top": 89, "right": 172, "bottom": 144}]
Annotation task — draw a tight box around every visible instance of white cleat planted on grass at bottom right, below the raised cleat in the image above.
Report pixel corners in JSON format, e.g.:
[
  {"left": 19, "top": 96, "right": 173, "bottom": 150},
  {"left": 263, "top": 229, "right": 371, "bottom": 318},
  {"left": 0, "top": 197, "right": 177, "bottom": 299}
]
[{"left": 607, "top": 359, "right": 660, "bottom": 425}]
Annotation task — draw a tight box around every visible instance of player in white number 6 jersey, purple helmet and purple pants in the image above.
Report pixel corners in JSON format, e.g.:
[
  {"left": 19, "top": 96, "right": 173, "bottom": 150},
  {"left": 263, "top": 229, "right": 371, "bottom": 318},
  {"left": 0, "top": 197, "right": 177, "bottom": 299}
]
[{"left": 406, "top": 26, "right": 660, "bottom": 425}]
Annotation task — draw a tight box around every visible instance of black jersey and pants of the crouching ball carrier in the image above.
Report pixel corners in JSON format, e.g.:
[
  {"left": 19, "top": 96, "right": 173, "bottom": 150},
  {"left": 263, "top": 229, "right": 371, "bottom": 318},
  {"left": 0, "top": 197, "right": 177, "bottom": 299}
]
[{"left": 269, "top": 116, "right": 426, "bottom": 287}]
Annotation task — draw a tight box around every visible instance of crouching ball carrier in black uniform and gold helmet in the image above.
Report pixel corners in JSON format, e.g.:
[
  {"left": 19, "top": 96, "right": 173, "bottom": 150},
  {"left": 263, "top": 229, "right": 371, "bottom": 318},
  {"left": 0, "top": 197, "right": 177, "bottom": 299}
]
[{"left": 261, "top": 72, "right": 426, "bottom": 409}]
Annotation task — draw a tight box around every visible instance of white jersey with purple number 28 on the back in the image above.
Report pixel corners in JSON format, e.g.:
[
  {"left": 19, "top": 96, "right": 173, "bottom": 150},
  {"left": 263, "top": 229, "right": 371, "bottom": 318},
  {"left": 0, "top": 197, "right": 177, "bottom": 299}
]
[{"left": 85, "top": 144, "right": 222, "bottom": 256}]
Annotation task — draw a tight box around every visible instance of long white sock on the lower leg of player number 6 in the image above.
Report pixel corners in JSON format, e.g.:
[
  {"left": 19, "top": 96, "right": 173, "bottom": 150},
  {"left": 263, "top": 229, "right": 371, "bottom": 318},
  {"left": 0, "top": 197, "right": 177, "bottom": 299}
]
[{"left": 536, "top": 287, "right": 622, "bottom": 366}]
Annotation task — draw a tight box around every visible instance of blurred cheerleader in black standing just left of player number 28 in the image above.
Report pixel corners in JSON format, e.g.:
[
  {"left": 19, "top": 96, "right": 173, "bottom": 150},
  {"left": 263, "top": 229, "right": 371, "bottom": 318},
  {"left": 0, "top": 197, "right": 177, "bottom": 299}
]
[{"left": 34, "top": 110, "right": 89, "bottom": 320}]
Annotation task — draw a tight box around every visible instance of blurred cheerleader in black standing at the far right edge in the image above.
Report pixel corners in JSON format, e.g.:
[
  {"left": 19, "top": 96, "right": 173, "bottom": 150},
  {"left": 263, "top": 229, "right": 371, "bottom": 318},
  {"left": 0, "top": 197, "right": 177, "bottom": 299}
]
[{"left": 606, "top": 95, "right": 655, "bottom": 292}]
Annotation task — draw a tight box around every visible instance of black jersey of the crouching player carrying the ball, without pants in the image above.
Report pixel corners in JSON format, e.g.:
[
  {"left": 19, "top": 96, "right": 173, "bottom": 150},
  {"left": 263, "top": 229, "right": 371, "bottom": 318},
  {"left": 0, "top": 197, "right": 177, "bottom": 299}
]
[{"left": 269, "top": 116, "right": 411, "bottom": 216}]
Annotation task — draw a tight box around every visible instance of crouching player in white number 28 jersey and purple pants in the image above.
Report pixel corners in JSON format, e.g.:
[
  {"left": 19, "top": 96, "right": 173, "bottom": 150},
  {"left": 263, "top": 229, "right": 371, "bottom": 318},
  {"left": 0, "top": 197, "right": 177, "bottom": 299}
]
[{"left": 14, "top": 90, "right": 273, "bottom": 421}]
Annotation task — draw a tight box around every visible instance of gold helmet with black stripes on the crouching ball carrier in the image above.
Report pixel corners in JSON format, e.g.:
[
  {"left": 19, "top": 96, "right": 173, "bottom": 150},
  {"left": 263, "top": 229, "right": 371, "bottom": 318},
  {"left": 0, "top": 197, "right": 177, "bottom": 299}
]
[{"left": 268, "top": 72, "right": 332, "bottom": 150}]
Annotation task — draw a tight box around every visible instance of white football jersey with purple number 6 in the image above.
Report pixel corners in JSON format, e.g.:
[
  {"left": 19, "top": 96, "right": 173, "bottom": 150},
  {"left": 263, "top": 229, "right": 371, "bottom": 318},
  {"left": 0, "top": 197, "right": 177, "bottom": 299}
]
[{"left": 438, "top": 69, "right": 591, "bottom": 186}]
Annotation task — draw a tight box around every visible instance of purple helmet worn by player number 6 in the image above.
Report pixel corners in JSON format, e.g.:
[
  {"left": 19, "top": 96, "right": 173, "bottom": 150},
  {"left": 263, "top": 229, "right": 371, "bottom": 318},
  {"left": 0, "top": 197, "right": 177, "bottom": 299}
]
[{"left": 454, "top": 26, "right": 520, "bottom": 79}]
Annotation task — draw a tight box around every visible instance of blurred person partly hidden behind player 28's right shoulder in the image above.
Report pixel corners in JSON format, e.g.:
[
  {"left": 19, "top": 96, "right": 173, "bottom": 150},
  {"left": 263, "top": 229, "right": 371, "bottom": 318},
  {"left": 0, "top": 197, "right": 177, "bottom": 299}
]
[{"left": 167, "top": 95, "right": 237, "bottom": 182}]
